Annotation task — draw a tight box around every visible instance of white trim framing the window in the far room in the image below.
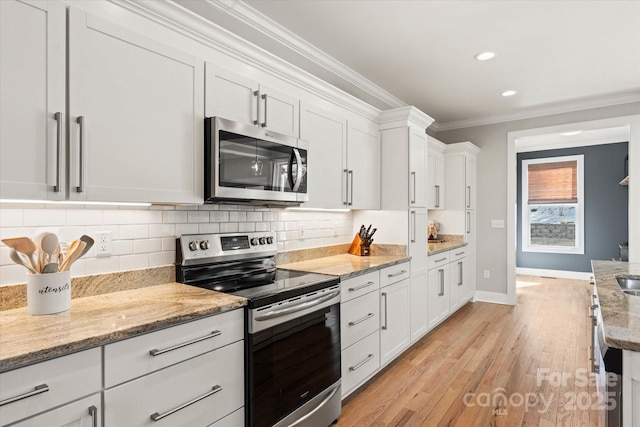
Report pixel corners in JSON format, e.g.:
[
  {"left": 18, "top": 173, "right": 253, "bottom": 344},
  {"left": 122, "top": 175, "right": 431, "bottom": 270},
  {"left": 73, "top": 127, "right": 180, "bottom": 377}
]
[{"left": 520, "top": 154, "right": 584, "bottom": 255}]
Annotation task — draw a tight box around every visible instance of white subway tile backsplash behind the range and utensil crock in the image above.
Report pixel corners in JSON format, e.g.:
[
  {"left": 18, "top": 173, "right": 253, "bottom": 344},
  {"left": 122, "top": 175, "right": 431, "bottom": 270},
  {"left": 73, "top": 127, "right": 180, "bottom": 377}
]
[{"left": 0, "top": 204, "right": 353, "bottom": 286}]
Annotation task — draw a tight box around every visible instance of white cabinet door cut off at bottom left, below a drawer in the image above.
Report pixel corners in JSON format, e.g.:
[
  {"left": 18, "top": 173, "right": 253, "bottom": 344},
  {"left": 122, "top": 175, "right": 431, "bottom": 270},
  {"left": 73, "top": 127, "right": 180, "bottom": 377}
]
[{"left": 13, "top": 393, "right": 102, "bottom": 427}]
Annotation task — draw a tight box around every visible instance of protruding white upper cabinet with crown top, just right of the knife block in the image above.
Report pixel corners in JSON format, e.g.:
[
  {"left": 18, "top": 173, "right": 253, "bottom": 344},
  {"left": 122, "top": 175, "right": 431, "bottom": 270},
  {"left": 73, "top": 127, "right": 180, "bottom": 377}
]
[{"left": 380, "top": 107, "right": 433, "bottom": 210}]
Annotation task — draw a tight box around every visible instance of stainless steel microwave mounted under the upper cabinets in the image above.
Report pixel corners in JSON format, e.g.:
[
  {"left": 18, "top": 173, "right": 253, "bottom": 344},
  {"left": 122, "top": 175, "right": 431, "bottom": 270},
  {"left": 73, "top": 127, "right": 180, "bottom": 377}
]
[{"left": 204, "top": 117, "right": 308, "bottom": 206}]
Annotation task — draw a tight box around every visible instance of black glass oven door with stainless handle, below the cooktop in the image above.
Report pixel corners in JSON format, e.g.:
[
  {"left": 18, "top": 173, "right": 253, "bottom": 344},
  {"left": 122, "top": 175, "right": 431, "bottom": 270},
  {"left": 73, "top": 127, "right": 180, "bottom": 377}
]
[{"left": 247, "top": 286, "right": 341, "bottom": 427}]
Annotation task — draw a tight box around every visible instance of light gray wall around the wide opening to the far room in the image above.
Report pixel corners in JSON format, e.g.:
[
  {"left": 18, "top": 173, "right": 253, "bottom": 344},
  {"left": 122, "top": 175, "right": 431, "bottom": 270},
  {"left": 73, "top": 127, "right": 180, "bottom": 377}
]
[{"left": 436, "top": 102, "right": 640, "bottom": 294}]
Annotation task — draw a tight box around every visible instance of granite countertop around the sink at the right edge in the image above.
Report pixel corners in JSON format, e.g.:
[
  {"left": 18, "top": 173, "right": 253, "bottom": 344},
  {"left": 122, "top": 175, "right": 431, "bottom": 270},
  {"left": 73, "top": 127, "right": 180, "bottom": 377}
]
[{"left": 591, "top": 261, "right": 640, "bottom": 351}]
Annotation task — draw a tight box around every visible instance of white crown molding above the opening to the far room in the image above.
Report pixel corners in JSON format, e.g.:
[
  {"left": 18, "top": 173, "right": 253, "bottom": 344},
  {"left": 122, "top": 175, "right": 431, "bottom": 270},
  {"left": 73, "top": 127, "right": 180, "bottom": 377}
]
[{"left": 432, "top": 90, "right": 640, "bottom": 132}]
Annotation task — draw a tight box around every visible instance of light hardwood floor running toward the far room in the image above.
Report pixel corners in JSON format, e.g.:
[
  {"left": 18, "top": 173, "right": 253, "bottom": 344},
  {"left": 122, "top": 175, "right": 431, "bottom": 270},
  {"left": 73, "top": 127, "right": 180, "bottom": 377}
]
[{"left": 337, "top": 276, "right": 604, "bottom": 427}]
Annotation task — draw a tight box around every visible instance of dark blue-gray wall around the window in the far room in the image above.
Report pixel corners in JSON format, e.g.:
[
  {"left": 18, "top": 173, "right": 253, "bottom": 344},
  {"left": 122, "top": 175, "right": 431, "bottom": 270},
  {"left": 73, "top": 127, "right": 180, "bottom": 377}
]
[{"left": 516, "top": 142, "right": 629, "bottom": 272}]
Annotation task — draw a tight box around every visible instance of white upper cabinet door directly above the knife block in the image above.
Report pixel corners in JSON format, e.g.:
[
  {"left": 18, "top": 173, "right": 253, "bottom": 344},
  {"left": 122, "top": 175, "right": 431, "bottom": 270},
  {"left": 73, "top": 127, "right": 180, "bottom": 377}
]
[{"left": 345, "top": 121, "right": 380, "bottom": 209}]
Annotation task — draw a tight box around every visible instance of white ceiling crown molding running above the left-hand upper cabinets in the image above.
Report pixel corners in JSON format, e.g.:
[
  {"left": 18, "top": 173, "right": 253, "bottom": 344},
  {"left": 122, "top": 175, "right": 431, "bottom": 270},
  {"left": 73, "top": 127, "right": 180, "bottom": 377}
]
[{"left": 205, "top": 0, "right": 407, "bottom": 112}]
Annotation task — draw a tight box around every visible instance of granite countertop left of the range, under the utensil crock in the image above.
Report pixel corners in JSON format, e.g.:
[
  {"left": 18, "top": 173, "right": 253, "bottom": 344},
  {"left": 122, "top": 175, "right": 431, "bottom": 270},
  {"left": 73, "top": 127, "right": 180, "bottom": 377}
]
[{"left": 0, "top": 283, "right": 247, "bottom": 372}]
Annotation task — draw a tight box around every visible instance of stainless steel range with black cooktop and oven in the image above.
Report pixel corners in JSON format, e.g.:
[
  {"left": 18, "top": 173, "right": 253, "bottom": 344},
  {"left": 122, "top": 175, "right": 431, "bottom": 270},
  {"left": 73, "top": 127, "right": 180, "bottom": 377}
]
[{"left": 176, "top": 232, "right": 341, "bottom": 427}]
